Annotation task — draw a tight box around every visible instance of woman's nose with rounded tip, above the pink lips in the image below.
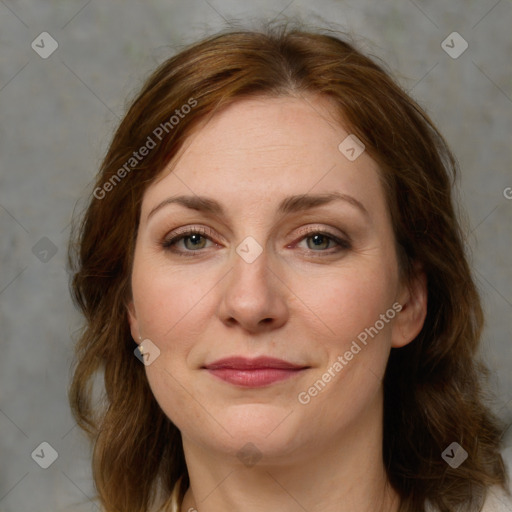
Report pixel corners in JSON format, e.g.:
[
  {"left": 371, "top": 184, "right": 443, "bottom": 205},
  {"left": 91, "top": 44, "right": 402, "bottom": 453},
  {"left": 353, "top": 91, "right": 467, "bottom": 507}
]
[{"left": 218, "top": 243, "right": 290, "bottom": 333}]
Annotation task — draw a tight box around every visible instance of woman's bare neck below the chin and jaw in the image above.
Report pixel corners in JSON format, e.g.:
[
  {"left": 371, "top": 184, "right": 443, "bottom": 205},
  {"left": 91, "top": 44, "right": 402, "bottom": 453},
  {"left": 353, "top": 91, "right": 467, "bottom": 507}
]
[{"left": 181, "top": 390, "right": 399, "bottom": 512}]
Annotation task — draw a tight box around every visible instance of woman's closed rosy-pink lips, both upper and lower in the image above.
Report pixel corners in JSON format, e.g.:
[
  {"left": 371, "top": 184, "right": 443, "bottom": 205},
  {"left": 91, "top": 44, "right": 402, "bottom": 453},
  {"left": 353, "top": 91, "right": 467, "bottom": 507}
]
[{"left": 203, "top": 357, "right": 309, "bottom": 388}]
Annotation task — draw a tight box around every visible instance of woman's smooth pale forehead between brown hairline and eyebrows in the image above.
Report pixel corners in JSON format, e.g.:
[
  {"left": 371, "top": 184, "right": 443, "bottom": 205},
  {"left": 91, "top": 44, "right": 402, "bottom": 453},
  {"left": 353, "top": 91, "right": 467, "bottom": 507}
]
[{"left": 143, "top": 96, "right": 382, "bottom": 218}]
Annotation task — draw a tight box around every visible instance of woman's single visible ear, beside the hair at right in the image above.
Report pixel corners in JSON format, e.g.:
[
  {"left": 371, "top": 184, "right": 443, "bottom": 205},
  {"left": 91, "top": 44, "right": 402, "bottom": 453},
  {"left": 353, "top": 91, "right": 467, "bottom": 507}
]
[{"left": 391, "top": 265, "right": 428, "bottom": 348}]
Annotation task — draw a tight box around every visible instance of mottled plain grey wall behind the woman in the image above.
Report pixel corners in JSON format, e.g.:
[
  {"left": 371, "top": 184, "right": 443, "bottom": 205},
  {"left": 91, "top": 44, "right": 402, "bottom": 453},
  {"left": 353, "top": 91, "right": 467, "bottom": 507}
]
[{"left": 0, "top": 0, "right": 512, "bottom": 512}]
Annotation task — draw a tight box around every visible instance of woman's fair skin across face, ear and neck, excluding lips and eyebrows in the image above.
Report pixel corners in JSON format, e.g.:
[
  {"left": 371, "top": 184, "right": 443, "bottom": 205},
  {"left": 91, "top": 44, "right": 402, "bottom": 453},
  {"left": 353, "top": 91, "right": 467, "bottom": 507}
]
[{"left": 128, "top": 97, "right": 426, "bottom": 512}]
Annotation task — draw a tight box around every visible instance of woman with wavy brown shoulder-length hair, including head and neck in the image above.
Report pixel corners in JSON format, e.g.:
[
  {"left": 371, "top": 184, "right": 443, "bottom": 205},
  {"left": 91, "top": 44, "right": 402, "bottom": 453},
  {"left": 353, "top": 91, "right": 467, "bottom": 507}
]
[{"left": 70, "top": 23, "right": 511, "bottom": 512}]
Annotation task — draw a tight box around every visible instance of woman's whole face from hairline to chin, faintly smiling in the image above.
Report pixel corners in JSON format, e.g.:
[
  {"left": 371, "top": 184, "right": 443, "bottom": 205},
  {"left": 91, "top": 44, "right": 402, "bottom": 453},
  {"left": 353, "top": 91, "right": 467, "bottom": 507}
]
[{"left": 129, "top": 97, "right": 424, "bottom": 460}]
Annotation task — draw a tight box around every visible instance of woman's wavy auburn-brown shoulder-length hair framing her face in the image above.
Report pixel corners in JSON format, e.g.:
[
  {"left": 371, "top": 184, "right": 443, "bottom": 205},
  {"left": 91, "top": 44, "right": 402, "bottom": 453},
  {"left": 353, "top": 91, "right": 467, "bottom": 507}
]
[{"left": 69, "top": 21, "right": 507, "bottom": 512}]
